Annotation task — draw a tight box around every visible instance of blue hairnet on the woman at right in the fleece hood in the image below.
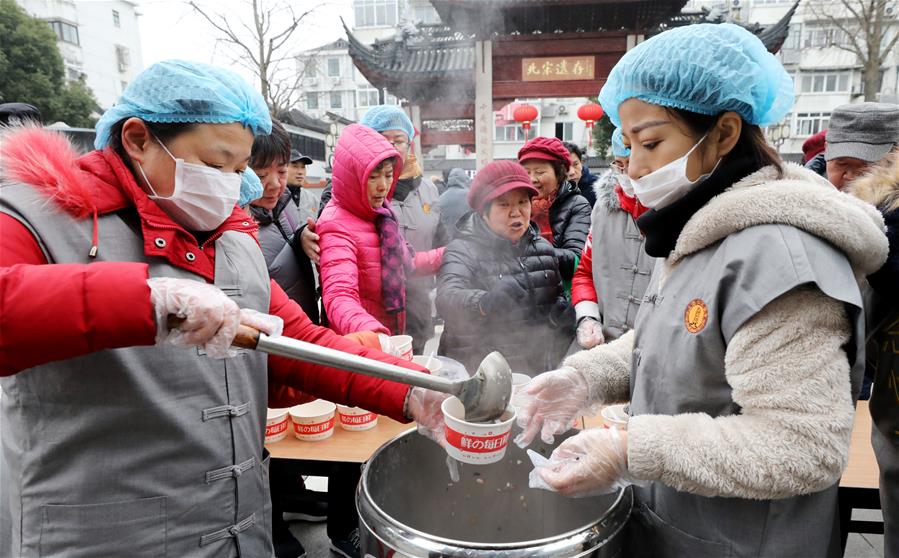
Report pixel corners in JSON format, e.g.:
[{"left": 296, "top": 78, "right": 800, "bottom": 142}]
[{"left": 599, "top": 23, "right": 794, "bottom": 127}]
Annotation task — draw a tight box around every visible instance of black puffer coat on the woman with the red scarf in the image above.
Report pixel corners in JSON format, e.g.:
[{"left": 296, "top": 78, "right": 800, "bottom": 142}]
[{"left": 549, "top": 180, "right": 591, "bottom": 281}]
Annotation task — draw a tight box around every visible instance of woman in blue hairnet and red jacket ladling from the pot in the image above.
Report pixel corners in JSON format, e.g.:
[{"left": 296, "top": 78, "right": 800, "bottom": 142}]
[{"left": 0, "top": 61, "right": 443, "bottom": 557}]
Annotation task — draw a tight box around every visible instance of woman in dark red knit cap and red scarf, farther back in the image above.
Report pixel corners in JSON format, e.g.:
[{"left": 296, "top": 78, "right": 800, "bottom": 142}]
[{"left": 518, "top": 137, "right": 590, "bottom": 283}]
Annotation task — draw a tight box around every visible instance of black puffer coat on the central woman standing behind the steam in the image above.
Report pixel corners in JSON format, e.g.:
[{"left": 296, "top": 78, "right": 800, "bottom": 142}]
[{"left": 437, "top": 213, "right": 574, "bottom": 374}]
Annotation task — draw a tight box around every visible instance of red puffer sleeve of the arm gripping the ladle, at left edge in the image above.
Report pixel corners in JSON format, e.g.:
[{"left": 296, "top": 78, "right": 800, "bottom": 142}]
[{"left": 0, "top": 215, "right": 156, "bottom": 376}]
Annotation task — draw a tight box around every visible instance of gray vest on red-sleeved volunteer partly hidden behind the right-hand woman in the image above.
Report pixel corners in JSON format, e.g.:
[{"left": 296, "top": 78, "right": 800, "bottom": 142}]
[{"left": 591, "top": 190, "right": 656, "bottom": 342}]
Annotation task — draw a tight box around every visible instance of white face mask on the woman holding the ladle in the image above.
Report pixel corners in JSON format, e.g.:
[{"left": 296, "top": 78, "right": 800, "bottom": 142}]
[{"left": 137, "top": 139, "right": 241, "bottom": 231}]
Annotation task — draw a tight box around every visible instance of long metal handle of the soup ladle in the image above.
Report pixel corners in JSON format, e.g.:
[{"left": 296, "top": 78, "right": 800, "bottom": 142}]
[{"left": 166, "top": 315, "right": 465, "bottom": 395}]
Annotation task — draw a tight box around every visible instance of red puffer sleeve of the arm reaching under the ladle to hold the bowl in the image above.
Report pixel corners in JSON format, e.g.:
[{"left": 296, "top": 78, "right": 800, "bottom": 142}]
[{"left": 268, "top": 281, "right": 427, "bottom": 422}]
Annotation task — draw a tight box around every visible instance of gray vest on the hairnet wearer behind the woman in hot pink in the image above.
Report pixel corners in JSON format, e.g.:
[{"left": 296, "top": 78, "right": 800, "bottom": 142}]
[{"left": 390, "top": 177, "right": 440, "bottom": 352}]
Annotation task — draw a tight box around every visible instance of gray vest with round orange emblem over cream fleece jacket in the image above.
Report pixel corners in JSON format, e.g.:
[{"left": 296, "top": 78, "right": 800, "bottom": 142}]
[{"left": 629, "top": 224, "right": 864, "bottom": 558}]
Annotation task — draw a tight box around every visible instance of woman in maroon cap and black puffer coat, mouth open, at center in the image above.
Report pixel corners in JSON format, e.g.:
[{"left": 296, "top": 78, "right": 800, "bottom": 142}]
[{"left": 437, "top": 161, "right": 586, "bottom": 374}]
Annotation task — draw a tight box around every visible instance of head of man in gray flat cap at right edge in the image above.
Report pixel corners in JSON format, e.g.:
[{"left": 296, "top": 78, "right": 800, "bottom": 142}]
[{"left": 824, "top": 103, "right": 899, "bottom": 190}]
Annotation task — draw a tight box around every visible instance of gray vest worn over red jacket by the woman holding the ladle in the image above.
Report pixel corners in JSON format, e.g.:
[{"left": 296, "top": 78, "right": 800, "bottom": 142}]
[{"left": 0, "top": 184, "right": 273, "bottom": 558}]
